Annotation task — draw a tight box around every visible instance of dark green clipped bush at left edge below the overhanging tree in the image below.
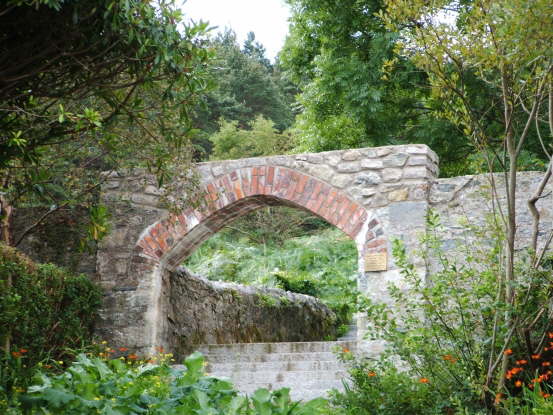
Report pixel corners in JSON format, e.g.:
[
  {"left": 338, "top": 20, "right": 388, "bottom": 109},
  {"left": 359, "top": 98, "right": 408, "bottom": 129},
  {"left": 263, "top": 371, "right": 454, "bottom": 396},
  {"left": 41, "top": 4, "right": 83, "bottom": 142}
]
[{"left": 0, "top": 245, "right": 101, "bottom": 408}]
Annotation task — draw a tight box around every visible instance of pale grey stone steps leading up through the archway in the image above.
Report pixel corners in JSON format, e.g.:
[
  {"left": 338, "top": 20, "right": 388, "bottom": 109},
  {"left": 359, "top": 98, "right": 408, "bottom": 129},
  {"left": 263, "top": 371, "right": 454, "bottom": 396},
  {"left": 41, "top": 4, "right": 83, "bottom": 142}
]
[{"left": 199, "top": 340, "right": 357, "bottom": 400}]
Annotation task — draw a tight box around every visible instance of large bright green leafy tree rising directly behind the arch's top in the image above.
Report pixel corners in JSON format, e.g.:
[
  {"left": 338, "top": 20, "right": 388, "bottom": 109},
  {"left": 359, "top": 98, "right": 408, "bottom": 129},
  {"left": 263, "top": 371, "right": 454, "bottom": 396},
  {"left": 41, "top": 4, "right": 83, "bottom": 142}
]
[{"left": 281, "top": 0, "right": 520, "bottom": 175}]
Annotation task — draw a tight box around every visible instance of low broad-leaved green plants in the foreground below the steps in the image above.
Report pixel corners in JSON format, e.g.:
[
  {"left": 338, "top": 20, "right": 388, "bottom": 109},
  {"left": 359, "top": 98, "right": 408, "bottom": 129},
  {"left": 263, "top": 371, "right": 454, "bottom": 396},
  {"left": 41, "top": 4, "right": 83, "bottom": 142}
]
[{"left": 13, "top": 353, "right": 326, "bottom": 415}]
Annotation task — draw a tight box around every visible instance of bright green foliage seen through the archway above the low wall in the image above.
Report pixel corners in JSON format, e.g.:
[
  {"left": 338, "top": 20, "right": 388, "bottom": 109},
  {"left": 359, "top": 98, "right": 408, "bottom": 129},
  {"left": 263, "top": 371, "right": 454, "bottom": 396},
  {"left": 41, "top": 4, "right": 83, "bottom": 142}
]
[{"left": 186, "top": 221, "right": 357, "bottom": 334}]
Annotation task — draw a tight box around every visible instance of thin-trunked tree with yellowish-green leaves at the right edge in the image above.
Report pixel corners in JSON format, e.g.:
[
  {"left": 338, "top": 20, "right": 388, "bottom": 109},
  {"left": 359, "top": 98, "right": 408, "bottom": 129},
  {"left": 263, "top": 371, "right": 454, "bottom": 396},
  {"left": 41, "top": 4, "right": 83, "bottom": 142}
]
[{"left": 380, "top": 0, "right": 553, "bottom": 404}]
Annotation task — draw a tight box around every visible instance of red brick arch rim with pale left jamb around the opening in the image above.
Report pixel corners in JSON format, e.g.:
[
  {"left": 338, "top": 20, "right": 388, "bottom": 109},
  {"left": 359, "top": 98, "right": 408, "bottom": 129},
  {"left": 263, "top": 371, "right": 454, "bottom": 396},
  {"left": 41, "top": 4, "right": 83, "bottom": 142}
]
[{"left": 128, "top": 165, "right": 387, "bottom": 353}]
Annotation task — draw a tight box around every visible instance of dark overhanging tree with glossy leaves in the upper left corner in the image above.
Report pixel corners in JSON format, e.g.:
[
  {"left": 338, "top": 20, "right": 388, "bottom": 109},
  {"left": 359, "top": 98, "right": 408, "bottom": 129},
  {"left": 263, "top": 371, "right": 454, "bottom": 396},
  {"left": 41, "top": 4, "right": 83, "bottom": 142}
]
[{"left": 0, "top": 0, "right": 210, "bottom": 247}]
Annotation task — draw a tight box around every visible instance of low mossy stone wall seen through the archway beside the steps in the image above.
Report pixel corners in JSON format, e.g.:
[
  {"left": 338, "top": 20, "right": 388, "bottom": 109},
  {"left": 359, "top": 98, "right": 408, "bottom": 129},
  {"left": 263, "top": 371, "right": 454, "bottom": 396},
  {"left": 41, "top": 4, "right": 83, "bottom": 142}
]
[{"left": 167, "top": 268, "right": 336, "bottom": 358}]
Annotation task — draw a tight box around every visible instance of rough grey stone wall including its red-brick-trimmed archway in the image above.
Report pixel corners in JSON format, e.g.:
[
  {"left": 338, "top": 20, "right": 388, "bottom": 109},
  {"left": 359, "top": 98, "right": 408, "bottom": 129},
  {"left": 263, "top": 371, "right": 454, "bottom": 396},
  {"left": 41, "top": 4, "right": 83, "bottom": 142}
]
[{"left": 90, "top": 145, "right": 551, "bottom": 353}]
